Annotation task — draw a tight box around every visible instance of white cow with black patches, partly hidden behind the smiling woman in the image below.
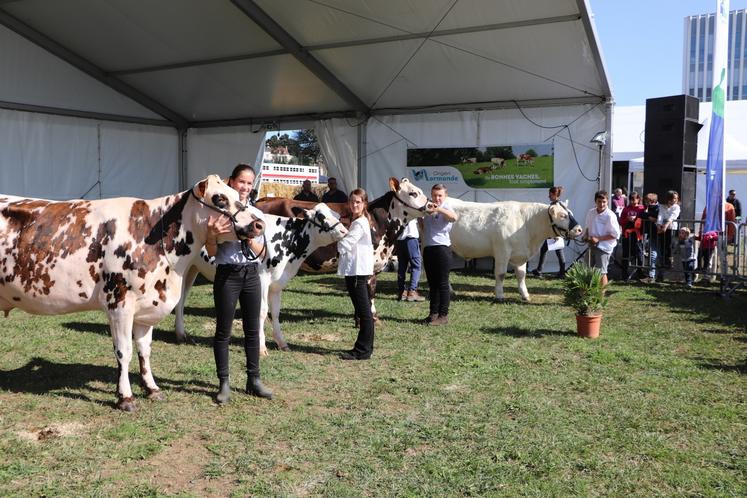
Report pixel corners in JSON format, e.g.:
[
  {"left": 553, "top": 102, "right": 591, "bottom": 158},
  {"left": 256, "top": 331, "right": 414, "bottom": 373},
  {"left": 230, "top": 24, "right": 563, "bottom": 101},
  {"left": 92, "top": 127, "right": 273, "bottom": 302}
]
[{"left": 176, "top": 204, "right": 348, "bottom": 356}]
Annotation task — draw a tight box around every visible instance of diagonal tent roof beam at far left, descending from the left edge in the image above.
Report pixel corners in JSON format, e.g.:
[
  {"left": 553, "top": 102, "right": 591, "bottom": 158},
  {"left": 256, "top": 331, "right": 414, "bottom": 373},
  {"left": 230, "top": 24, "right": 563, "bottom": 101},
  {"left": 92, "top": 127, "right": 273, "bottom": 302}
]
[{"left": 0, "top": 9, "right": 188, "bottom": 128}]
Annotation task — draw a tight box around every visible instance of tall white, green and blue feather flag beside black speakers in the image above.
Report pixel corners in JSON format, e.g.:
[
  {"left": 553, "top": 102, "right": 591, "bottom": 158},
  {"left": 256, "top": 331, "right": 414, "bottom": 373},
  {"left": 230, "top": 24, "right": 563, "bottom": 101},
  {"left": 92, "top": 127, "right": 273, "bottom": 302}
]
[{"left": 703, "top": 0, "right": 729, "bottom": 233}]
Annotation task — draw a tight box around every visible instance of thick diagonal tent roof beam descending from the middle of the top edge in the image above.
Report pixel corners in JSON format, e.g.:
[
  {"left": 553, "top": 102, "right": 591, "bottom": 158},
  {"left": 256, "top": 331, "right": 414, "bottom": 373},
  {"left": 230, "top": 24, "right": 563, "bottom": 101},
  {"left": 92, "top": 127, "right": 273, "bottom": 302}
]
[{"left": 231, "top": 0, "right": 370, "bottom": 114}]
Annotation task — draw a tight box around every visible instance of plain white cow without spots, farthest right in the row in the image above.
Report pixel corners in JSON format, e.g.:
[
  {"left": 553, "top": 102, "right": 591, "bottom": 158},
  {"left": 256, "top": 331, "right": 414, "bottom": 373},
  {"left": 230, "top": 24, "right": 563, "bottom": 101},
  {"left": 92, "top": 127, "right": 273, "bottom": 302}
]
[{"left": 448, "top": 198, "right": 581, "bottom": 301}]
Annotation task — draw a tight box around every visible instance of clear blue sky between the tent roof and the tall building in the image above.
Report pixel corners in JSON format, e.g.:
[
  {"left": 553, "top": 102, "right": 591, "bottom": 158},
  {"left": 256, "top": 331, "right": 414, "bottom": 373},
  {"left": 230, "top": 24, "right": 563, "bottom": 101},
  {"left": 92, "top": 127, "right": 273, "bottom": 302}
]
[{"left": 589, "top": 0, "right": 747, "bottom": 106}]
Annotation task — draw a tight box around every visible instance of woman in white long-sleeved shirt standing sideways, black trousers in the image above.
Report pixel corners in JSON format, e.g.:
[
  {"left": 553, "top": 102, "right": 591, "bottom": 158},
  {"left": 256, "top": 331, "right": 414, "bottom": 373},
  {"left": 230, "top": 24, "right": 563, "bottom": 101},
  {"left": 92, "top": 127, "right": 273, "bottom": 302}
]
[{"left": 337, "top": 188, "right": 374, "bottom": 360}]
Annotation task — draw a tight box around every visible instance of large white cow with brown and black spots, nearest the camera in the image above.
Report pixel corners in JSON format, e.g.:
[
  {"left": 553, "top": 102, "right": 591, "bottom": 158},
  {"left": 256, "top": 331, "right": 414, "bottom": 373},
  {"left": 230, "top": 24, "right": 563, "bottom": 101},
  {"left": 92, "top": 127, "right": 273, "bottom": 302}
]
[{"left": 0, "top": 175, "right": 264, "bottom": 411}]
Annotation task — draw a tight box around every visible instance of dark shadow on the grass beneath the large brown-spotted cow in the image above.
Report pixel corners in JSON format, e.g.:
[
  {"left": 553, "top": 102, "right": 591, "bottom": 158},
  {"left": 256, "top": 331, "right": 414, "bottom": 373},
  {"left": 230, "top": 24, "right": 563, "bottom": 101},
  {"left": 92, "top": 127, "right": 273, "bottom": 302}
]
[{"left": 0, "top": 358, "right": 215, "bottom": 408}]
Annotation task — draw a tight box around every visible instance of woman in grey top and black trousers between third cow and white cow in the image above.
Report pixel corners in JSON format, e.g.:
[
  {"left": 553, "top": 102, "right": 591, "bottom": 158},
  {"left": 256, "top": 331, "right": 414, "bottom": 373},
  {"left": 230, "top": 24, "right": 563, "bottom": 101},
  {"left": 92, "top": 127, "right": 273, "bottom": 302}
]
[{"left": 423, "top": 183, "right": 457, "bottom": 325}]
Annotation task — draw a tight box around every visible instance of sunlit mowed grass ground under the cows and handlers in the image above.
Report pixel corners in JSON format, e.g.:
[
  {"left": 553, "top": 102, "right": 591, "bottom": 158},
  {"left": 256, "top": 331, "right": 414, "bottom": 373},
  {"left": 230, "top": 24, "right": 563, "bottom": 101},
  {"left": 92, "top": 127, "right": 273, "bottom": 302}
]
[{"left": 0, "top": 273, "right": 747, "bottom": 496}]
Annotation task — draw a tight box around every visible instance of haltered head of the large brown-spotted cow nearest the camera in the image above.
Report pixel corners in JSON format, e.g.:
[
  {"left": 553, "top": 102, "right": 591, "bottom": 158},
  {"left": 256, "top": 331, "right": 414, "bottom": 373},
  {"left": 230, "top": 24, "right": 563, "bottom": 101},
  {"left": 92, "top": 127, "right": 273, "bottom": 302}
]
[{"left": 192, "top": 175, "right": 265, "bottom": 242}]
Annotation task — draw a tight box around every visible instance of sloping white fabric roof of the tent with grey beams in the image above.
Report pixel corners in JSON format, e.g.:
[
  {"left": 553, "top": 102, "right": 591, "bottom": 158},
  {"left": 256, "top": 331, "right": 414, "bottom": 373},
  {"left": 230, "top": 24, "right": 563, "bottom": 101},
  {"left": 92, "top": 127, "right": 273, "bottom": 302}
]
[{"left": 0, "top": 0, "right": 611, "bottom": 127}]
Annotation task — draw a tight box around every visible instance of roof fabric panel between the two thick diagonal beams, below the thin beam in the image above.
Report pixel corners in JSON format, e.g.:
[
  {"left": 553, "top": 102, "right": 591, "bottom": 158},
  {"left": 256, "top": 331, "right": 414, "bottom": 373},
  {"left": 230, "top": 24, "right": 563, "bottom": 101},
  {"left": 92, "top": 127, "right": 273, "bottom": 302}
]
[{"left": 122, "top": 55, "right": 348, "bottom": 121}]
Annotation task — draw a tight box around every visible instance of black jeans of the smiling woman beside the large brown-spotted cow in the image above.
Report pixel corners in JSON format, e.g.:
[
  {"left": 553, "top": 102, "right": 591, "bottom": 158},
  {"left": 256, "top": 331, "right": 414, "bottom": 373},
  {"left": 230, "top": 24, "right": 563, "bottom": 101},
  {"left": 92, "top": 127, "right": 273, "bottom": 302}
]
[{"left": 213, "top": 264, "right": 262, "bottom": 380}]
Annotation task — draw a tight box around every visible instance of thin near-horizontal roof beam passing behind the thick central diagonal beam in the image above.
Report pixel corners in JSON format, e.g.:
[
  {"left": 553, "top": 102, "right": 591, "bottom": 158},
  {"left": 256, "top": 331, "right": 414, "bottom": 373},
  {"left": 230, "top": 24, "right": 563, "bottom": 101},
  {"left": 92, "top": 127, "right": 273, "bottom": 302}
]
[{"left": 111, "top": 14, "right": 581, "bottom": 76}]
